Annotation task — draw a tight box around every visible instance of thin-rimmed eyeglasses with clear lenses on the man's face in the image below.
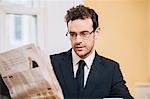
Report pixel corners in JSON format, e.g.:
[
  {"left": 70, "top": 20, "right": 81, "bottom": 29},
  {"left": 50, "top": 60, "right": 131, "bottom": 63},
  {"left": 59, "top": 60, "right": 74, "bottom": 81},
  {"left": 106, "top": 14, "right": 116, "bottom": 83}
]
[{"left": 66, "top": 31, "right": 94, "bottom": 39}]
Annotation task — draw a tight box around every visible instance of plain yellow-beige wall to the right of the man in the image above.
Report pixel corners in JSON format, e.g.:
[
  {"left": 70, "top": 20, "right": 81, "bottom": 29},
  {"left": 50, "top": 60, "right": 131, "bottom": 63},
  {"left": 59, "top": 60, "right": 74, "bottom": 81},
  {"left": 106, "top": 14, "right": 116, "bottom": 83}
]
[{"left": 84, "top": 0, "right": 150, "bottom": 96}]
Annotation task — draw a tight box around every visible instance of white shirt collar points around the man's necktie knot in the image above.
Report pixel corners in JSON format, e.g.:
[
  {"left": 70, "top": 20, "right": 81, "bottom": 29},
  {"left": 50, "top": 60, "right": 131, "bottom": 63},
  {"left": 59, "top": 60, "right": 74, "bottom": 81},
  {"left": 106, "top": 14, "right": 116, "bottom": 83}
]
[{"left": 72, "top": 49, "right": 95, "bottom": 68}]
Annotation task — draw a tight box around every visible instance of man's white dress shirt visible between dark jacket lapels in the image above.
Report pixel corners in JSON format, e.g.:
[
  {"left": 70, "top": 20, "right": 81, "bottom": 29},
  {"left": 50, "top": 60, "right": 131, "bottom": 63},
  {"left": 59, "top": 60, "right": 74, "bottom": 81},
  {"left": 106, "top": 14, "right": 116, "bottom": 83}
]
[{"left": 72, "top": 49, "right": 95, "bottom": 86}]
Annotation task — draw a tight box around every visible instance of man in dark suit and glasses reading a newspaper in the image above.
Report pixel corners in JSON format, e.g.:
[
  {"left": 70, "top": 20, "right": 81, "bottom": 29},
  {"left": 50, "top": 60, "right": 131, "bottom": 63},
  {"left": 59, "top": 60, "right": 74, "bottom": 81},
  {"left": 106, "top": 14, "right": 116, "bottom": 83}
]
[{"left": 50, "top": 5, "right": 133, "bottom": 99}]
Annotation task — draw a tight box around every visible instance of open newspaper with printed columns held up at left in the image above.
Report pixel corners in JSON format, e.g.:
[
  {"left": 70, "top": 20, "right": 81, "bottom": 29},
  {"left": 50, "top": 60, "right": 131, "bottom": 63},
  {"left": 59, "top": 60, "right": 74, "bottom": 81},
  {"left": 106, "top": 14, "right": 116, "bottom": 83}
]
[{"left": 0, "top": 44, "right": 63, "bottom": 99}]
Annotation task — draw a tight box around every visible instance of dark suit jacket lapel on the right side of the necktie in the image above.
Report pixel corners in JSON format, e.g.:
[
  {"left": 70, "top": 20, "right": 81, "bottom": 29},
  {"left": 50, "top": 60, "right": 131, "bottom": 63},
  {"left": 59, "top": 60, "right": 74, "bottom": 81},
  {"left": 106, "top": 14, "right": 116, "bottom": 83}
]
[{"left": 82, "top": 53, "right": 103, "bottom": 97}]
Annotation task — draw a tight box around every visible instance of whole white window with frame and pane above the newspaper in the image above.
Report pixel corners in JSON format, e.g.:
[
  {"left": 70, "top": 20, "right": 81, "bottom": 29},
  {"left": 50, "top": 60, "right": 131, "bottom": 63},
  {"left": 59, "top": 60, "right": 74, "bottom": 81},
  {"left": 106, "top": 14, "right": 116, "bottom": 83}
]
[{"left": 0, "top": 0, "right": 43, "bottom": 51}]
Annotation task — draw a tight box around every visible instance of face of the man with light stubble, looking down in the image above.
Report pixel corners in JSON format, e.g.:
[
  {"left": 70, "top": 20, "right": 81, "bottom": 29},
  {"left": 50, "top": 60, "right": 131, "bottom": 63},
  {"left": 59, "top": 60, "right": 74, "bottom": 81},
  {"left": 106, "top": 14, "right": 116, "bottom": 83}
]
[{"left": 68, "top": 18, "right": 95, "bottom": 59}]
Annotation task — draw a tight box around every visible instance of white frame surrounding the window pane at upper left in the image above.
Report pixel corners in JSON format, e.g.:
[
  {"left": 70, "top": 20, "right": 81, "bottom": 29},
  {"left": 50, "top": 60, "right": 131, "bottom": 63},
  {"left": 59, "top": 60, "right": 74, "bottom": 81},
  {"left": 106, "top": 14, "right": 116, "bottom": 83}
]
[{"left": 0, "top": 3, "right": 45, "bottom": 51}]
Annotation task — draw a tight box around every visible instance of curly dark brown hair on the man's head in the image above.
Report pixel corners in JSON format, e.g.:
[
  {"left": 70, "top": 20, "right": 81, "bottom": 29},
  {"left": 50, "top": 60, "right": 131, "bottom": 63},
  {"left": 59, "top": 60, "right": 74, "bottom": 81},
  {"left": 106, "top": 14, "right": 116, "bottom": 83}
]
[{"left": 65, "top": 5, "right": 99, "bottom": 30}]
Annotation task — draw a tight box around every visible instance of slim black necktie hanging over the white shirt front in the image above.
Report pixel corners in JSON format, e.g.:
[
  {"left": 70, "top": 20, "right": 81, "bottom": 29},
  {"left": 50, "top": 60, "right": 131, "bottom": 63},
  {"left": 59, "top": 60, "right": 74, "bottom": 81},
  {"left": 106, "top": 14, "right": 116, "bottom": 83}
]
[{"left": 76, "top": 60, "right": 86, "bottom": 95}]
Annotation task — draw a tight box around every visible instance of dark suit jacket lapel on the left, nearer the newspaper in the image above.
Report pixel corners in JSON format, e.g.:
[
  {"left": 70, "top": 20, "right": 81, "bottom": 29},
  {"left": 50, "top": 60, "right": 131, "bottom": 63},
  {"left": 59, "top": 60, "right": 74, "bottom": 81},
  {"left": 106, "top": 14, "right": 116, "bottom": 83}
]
[{"left": 61, "top": 50, "right": 77, "bottom": 97}]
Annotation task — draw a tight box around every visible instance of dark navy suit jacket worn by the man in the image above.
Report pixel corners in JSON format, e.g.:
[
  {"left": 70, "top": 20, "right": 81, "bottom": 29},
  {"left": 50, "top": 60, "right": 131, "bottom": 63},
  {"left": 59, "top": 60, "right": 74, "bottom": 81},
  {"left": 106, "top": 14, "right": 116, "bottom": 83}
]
[{"left": 50, "top": 50, "right": 133, "bottom": 99}]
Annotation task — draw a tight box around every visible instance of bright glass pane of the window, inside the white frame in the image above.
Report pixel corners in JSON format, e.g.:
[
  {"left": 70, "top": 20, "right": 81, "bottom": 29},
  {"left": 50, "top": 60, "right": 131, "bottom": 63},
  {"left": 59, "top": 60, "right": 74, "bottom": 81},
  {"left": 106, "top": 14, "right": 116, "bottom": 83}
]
[{"left": 6, "top": 14, "right": 37, "bottom": 47}]
